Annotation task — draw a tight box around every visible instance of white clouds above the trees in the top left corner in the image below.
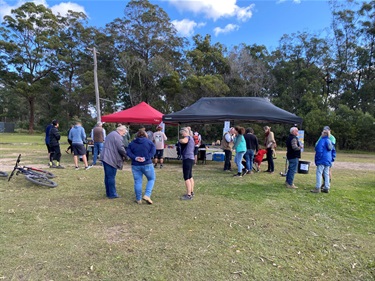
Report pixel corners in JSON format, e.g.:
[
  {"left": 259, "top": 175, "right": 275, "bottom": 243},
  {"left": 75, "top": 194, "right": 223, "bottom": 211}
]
[{"left": 0, "top": 0, "right": 87, "bottom": 22}]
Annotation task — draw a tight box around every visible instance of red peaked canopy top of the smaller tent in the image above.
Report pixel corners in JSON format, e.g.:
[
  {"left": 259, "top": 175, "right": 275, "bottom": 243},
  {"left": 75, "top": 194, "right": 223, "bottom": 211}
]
[{"left": 102, "top": 102, "right": 163, "bottom": 124}]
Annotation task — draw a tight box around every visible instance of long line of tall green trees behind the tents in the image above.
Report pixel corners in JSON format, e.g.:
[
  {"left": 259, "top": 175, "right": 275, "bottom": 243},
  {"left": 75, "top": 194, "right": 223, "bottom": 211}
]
[{"left": 0, "top": 0, "right": 375, "bottom": 150}]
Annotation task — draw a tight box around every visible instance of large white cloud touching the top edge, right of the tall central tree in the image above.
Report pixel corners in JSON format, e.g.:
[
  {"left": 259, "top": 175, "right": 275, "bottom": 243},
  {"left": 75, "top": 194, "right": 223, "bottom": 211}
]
[{"left": 167, "top": 0, "right": 255, "bottom": 21}]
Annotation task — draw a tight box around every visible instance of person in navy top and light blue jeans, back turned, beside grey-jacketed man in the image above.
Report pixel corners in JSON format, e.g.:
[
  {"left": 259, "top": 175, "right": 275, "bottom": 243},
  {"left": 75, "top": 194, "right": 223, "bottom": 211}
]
[{"left": 126, "top": 130, "right": 156, "bottom": 204}]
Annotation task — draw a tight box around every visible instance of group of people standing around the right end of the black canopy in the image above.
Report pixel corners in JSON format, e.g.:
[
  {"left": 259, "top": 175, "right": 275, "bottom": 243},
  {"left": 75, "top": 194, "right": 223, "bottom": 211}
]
[{"left": 221, "top": 126, "right": 336, "bottom": 193}]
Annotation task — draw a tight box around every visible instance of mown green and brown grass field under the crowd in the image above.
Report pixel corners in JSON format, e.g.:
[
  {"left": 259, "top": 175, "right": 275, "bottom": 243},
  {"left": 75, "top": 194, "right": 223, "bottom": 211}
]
[{"left": 0, "top": 136, "right": 375, "bottom": 280}]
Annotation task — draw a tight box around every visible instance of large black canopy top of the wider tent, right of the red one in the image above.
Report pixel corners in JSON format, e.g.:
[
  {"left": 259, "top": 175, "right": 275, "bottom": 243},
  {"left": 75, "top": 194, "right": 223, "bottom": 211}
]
[{"left": 163, "top": 97, "right": 303, "bottom": 124}]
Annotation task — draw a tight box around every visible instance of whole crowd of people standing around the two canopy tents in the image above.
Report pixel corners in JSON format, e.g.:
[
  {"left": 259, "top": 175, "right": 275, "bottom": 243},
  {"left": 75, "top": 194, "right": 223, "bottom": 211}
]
[{"left": 45, "top": 120, "right": 336, "bottom": 204}]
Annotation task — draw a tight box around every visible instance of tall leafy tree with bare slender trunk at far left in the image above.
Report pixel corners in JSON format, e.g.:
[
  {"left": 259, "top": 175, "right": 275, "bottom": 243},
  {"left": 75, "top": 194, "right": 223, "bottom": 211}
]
[{"left": 0, "top": 2, "right": 61, "bottom": 133}]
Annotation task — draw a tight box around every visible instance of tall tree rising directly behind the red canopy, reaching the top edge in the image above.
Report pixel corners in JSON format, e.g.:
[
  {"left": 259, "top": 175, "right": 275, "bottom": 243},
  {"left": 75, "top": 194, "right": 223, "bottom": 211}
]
[{"left": 106, "top": 0, "right": 184, "bottom": 105}]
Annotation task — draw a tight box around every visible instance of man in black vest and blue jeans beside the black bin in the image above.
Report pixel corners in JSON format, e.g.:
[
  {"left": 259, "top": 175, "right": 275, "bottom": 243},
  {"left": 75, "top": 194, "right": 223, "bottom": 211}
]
[{"left": 285, "top": 127, "right": 301, "bottom": 189}]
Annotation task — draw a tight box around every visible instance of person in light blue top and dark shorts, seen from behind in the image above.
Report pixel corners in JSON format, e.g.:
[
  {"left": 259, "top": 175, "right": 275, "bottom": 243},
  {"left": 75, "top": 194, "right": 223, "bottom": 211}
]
[{"left": 69, "top": 121, "right": 92, "bottom": 170}]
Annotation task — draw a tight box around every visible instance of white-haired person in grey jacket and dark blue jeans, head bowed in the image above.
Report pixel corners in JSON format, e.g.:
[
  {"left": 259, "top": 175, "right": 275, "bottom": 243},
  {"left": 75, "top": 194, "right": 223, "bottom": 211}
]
[{"left": 100, "top": 125, "right": 128, "bottom": 199}]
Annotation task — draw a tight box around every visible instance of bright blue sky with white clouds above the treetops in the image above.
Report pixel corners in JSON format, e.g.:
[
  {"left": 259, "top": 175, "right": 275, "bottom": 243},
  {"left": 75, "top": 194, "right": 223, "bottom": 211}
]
[{"left": 0, "top": 0, "right": 331, "bottom": 50}]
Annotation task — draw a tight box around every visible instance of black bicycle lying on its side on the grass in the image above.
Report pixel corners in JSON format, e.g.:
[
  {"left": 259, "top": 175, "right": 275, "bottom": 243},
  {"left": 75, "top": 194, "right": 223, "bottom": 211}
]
[{"left": 8, "top": 154, "right": 57, "bottom": 187}]
